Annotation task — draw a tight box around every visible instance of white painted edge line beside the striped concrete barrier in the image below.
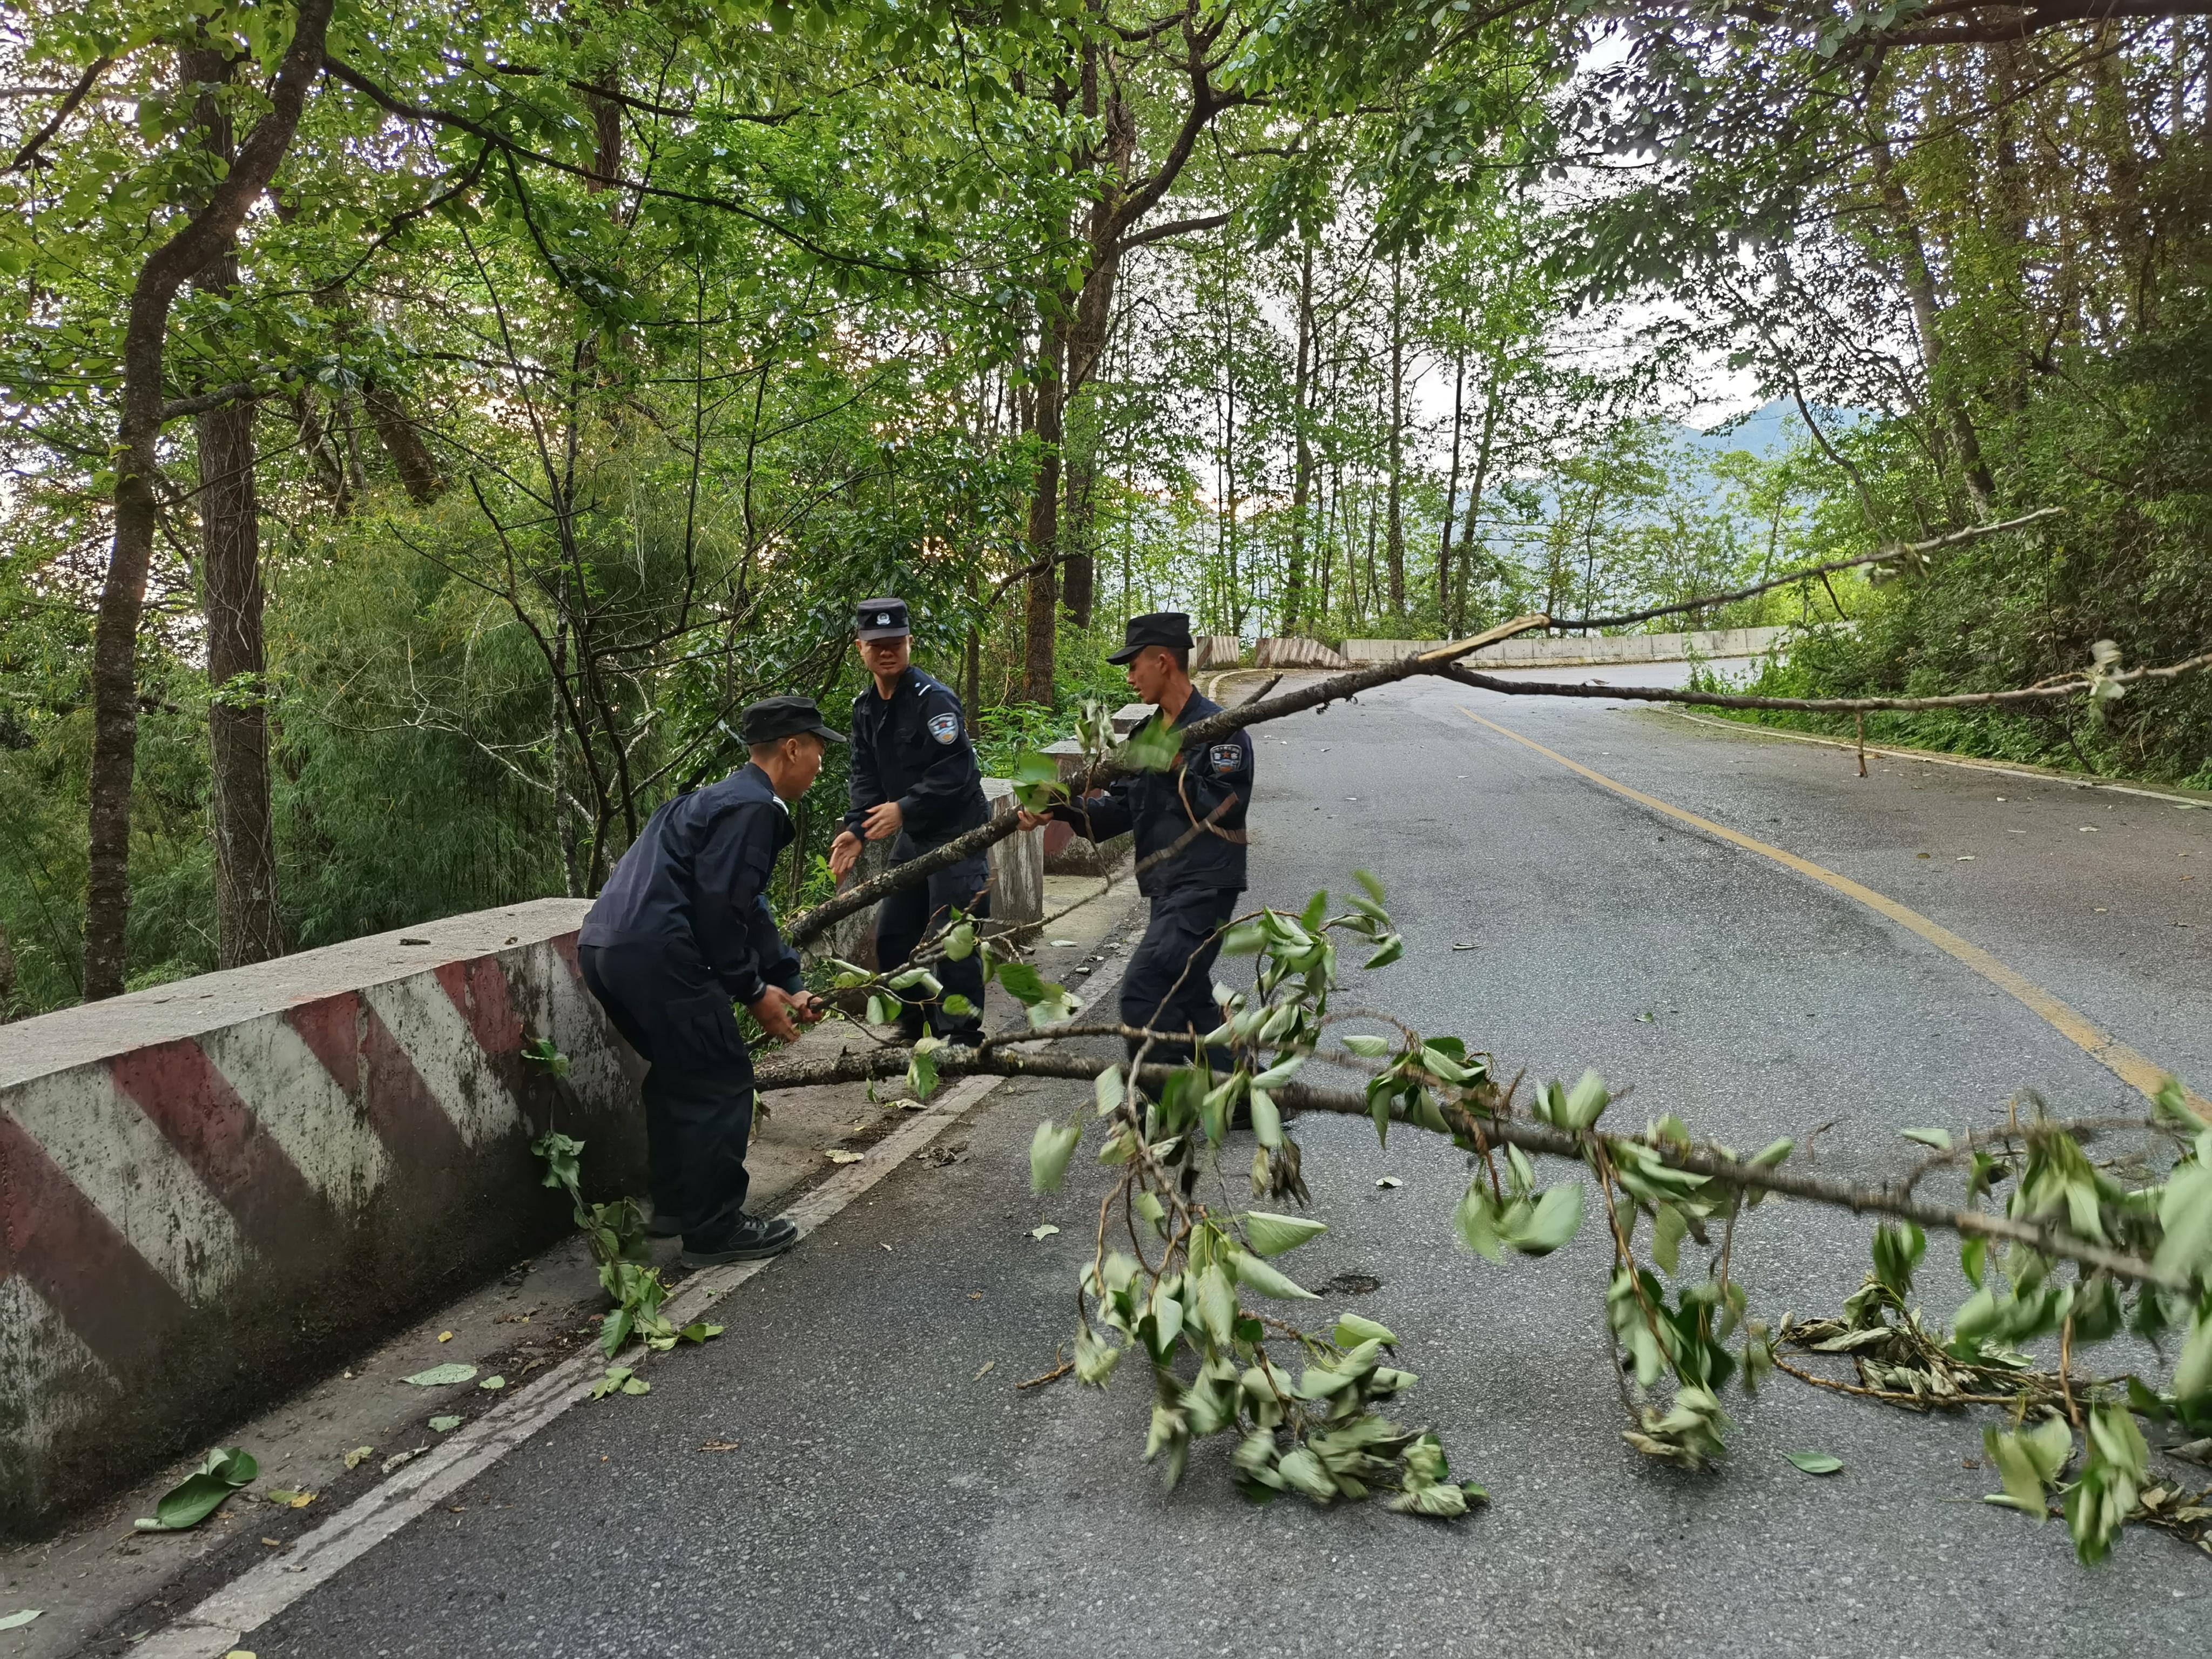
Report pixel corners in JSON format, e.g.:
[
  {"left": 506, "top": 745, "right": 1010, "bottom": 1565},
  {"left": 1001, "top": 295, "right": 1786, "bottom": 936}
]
[{"left": 131, "top": 929, "right": 1115, "bottom": 1659}]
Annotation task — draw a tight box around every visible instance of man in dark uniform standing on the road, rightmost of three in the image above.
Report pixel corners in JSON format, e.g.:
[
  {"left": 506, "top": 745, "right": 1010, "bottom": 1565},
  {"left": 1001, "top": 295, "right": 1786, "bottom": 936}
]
[{"left": 1022, "top": 610, "right": 1252, "bottom": 1062}]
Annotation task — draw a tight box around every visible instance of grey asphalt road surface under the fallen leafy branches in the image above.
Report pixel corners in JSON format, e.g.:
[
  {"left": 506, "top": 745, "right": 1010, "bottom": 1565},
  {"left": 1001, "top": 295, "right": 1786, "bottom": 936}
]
[{"left": 211, "top": 672, "right": 2212, "bottom": 1659}]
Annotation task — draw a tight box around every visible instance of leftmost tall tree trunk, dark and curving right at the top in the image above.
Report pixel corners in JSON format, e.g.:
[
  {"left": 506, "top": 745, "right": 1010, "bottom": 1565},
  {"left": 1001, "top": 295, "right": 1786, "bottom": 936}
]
[{"left": 84, "top": 16, "right": 334, "bottom": 1000}]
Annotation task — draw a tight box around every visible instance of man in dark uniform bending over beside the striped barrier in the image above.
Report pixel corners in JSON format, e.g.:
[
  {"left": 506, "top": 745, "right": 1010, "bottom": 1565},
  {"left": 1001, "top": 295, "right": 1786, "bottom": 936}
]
[{"left": 577, "top": 697, "right": 845, "bottom": 1267}]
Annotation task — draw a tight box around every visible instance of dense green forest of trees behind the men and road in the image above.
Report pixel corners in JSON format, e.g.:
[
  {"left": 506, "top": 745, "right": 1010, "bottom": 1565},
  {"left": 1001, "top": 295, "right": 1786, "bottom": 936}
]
[{"left": 0, "top": 0, "right": 2212, "bottom": 1017}]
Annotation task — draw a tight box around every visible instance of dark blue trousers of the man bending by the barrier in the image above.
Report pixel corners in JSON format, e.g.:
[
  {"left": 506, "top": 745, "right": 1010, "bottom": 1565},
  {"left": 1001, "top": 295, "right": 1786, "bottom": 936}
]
[{"left": 577, "top": 945, "right": 752, "bottom": 1250}]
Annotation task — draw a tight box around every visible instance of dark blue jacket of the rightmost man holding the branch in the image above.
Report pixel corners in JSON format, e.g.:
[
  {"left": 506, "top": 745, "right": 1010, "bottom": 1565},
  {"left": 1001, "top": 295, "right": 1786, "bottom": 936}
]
[{"left": 1053, "top": 692, "right": 1252, "bottom": 898}]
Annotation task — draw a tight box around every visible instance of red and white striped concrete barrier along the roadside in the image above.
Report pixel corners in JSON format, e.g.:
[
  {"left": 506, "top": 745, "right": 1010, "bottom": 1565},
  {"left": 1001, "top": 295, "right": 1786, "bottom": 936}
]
[{"left": 0, "top": 898, "right": 644, "bottom": 1535}]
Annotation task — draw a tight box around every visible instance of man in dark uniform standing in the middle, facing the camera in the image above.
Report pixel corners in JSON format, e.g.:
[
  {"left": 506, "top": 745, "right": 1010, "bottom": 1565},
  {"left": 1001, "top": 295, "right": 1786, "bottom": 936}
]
[{"left": 830, "top": 599, "right": 991, "bottom": 1044}]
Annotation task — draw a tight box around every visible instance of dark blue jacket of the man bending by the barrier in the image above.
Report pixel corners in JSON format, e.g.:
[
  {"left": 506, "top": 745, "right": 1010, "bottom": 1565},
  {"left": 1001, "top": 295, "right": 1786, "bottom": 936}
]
[{"left": 577, "top": 763, "right": 799, "bottom": 1002}]
